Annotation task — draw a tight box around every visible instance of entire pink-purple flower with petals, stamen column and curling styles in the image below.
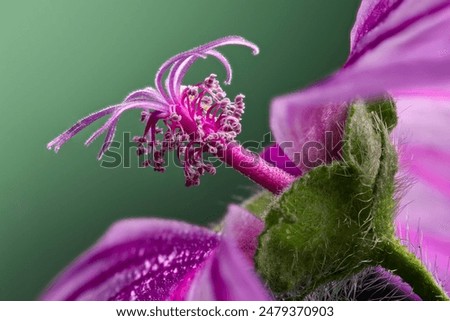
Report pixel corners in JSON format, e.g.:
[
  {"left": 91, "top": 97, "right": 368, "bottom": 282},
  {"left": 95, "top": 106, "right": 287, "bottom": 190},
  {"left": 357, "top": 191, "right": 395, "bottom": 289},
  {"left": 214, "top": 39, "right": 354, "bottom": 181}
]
[{"left": 43, "top": 0, "right": 450, "bottom": 300}]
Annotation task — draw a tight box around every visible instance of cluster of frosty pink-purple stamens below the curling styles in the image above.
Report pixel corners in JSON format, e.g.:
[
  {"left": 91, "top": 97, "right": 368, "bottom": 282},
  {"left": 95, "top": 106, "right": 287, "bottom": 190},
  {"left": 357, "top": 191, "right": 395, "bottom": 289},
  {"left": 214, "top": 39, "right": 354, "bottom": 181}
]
[{"left": 134, "top": 74, "right": 245, "bottom": 186}]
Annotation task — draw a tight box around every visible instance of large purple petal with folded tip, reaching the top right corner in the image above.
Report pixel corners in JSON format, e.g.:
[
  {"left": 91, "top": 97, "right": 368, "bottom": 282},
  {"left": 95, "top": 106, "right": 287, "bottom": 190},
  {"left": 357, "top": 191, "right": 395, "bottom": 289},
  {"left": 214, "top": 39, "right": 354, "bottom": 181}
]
[{"left": 271, "top": 0, "right": 450, "bottom": 165}]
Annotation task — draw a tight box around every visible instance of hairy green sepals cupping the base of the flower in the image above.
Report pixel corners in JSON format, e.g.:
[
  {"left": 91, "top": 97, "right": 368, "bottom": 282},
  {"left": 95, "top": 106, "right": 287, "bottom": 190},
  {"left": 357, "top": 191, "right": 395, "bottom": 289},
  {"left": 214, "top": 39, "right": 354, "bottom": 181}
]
[{"left": 256, "top": 102, "right": 397, "bottom": 299}]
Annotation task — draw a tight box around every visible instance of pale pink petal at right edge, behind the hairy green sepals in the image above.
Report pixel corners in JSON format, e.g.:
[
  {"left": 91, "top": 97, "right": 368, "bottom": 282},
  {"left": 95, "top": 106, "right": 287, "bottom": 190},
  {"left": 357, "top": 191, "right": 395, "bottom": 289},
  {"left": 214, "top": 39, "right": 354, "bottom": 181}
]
[{"left": 394, "top": 92, "right": 450, "bottom": 293}]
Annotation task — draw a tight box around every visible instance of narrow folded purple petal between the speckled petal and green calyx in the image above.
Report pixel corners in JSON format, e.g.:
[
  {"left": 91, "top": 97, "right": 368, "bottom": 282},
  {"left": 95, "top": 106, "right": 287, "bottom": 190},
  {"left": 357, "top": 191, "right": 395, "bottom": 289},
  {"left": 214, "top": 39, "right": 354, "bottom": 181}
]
[{"left": 187, "top": 204, "right": 272, "bottom": 301}]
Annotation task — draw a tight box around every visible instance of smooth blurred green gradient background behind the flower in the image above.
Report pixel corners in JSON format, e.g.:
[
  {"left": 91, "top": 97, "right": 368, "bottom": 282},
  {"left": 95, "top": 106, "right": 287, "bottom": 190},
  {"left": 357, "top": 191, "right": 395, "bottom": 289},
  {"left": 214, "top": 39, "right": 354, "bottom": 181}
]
[{"left": 0, "top": 0, "right": 359, "bottom": 300}]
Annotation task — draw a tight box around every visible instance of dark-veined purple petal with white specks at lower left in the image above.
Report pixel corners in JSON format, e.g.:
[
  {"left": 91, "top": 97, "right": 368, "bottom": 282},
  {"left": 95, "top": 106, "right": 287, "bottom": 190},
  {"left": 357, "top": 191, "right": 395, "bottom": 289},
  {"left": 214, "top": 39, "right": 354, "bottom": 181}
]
[{"left": 42, "top": 219, "right": 219, "bottom": 300}]
